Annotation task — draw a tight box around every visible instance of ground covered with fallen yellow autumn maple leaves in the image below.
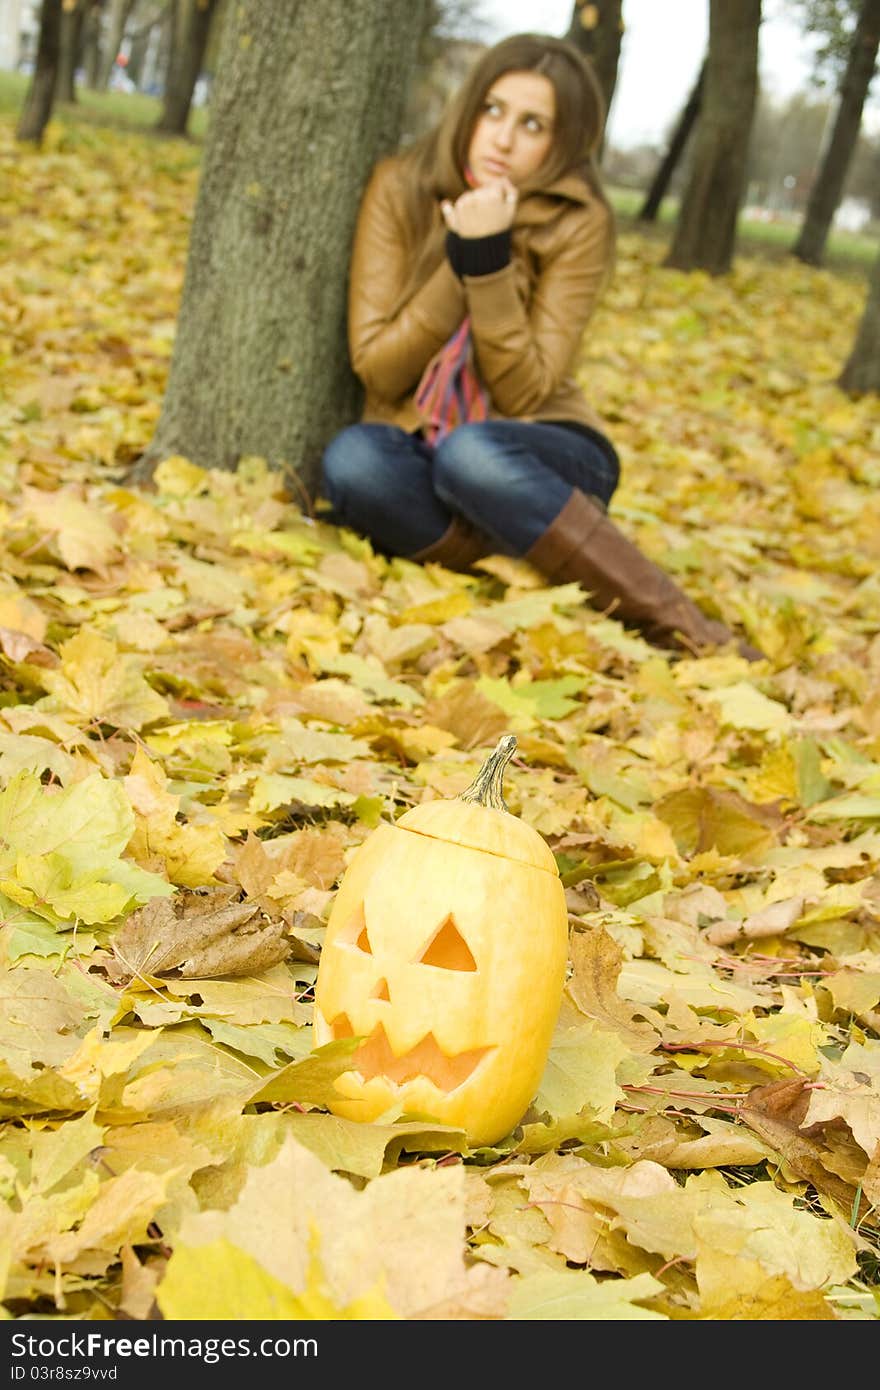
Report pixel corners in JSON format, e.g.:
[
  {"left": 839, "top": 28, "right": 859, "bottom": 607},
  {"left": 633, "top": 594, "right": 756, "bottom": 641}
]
[{"left": 0, "top": 122, "right": 880, "bottom": 1321}]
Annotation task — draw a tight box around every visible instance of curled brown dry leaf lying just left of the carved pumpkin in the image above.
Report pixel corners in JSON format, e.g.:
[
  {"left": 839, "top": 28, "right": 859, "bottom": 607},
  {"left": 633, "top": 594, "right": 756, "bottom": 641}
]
[{"left": 113, "top": 890, "right": 291, "bottom": 979}]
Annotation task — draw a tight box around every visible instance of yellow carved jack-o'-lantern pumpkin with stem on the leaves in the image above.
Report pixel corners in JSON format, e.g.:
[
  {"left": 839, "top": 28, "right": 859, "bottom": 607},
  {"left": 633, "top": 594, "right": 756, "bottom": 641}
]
[{"left": 314, "top": 735, "right": 569, "bottom": 1144}]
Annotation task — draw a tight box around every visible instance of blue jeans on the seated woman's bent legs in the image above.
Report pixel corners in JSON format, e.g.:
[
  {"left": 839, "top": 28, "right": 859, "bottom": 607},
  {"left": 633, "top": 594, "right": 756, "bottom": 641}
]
[{"left": 323, "top": 420, "right": 620, "bottom": 555}]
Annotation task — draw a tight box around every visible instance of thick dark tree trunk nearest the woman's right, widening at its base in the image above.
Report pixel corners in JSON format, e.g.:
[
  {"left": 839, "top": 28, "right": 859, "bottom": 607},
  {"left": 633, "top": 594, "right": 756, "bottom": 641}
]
[{"left": 663, "top": 0, "right": 760, "bottom": 275}]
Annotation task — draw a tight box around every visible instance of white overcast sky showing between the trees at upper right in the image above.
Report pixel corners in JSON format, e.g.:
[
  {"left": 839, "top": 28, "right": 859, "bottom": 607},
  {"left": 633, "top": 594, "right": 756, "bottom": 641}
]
[{"left": 474, "top": 0, "right": 880, "bottom": 147}]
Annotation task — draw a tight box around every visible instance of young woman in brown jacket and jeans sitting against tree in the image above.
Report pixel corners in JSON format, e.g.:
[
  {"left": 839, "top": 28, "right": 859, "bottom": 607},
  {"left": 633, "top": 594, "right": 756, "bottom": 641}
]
[{"left": 323, "top": 33, "right": 759, "bottom": 655}]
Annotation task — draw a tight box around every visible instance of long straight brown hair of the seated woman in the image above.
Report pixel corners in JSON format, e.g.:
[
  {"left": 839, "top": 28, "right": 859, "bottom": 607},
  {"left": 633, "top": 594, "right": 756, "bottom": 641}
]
[{"left": 392, "top": 33, "right": 613, "bottom": 269}]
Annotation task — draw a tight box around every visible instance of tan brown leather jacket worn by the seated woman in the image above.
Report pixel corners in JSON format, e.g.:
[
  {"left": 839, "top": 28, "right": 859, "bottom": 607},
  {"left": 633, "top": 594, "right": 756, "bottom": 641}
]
[{"left": 343, "top": 156, "right": 610, "bottom": 432}]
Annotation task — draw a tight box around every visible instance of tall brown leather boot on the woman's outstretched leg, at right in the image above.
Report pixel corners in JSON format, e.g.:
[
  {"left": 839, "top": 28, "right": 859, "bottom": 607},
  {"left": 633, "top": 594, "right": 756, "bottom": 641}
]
[{"left": 524, "top": 488, "right": 763, "bottom": 662}]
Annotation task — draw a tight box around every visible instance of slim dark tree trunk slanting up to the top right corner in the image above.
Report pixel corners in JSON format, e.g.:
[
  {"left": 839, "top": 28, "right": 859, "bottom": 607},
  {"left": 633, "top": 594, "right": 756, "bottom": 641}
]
[{"left": 792, "top": 0, "right": 880, "bottom": 265}]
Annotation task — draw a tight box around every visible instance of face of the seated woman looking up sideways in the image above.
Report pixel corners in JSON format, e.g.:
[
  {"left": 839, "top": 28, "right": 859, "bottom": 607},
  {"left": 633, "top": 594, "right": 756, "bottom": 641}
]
[{"left": 467, "top": 72, "right": 556, "bottom": 186}]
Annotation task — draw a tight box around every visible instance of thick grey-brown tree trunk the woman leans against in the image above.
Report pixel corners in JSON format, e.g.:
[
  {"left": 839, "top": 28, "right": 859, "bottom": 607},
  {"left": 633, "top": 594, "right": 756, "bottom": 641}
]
[{"left": 131, "top": 0, "right": 424, "bottom": 495}]
